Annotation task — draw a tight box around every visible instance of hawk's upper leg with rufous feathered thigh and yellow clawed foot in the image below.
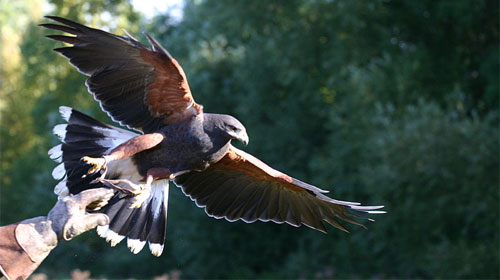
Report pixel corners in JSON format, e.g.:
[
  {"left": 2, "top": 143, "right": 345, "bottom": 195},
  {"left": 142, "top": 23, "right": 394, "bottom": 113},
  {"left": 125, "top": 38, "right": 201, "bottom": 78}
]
[{"left": 82, "top": 133, "right": 165, "bottom": 174}]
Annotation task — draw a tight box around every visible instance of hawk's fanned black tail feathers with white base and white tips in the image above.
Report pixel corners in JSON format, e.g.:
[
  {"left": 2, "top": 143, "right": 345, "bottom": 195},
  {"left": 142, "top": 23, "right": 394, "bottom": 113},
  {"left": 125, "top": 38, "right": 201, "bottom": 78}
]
[{"left": 49, "top": 106, "right": 169, "bottom": 256}]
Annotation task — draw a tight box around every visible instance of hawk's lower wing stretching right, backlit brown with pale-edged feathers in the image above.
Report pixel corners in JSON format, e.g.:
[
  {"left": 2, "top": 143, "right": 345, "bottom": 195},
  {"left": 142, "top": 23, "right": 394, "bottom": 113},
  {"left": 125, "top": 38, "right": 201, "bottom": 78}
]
[{"left": 175, "top": 146, "right": 385, "bottom": 233}]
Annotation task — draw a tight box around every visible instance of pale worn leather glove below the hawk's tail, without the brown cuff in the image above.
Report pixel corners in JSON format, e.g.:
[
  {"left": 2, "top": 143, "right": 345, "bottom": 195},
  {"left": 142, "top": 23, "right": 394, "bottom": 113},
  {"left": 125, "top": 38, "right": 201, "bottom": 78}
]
[{"left": 16, "top": 188, "right": 113, "bottom": 263}]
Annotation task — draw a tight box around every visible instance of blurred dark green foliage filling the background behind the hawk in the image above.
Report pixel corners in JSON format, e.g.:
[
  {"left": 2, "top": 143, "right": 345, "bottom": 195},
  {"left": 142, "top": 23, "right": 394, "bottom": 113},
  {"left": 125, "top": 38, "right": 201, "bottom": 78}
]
[{"left": 0, "top": 0, "right": 500, "bottom": 278}]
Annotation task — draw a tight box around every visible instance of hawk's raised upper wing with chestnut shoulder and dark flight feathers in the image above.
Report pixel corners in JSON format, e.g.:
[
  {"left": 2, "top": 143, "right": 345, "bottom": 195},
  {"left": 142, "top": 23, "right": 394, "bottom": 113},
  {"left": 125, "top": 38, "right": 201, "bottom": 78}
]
[{"left": 41, "top": 16, "right": 202, "bottom": 132}]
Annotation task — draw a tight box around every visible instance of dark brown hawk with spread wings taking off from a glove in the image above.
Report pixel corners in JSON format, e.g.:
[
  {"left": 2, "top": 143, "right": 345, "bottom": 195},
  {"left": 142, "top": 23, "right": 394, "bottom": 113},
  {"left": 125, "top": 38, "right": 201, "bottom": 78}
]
[{"left": 41, "top": 16, "right": 384, "bottom": 256}]
